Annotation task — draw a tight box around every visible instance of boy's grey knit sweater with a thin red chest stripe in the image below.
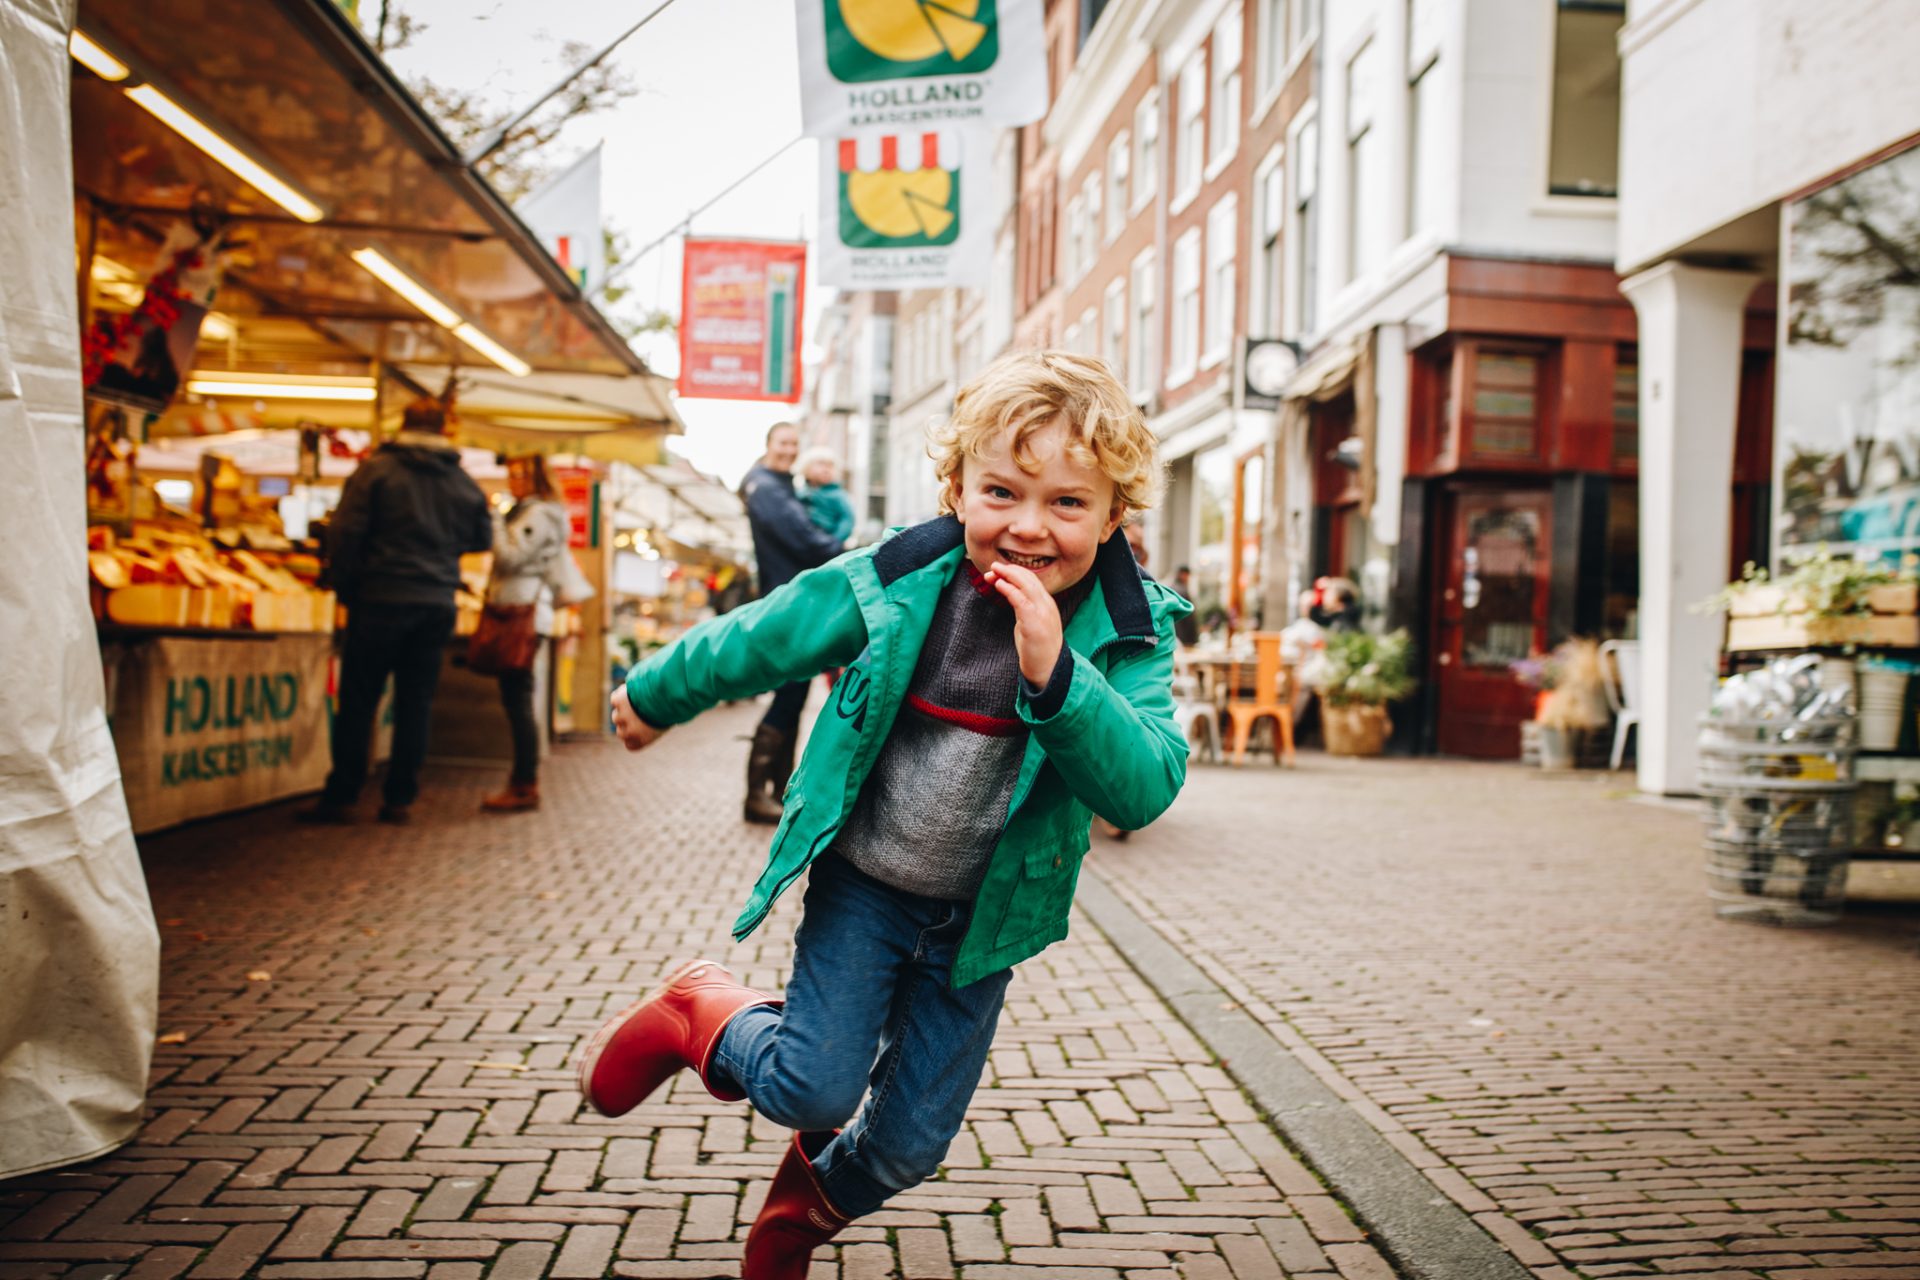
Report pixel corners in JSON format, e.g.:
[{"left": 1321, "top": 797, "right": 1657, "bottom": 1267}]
[{"left": 831, "top": 560, "right": 1092, "bottom": 900}]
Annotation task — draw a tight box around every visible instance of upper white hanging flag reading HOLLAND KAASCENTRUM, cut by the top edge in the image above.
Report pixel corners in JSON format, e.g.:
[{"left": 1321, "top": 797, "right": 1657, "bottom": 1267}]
[{"left": 795, "top": 0, "right": 1046, "bottom": 138}]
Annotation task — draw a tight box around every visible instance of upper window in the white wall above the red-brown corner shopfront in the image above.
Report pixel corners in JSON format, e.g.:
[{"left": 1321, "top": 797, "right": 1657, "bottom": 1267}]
[{"left": 1548, "top": 0, "right": 1626, "bottom": 196}]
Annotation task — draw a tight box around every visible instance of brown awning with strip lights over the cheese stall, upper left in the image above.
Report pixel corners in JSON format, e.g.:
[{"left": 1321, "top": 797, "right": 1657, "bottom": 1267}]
[{"left": 73, "top": 0, "right": 647, "bottom": 385}]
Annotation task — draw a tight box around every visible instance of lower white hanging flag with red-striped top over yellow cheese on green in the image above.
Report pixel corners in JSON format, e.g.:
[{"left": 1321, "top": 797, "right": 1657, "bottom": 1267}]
[{"left": 820, "top": 129, "right": 993, "bottom": 290}]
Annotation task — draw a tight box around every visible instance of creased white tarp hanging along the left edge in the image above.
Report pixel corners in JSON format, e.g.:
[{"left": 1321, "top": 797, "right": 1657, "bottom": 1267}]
[{"left": 0, "top": 0, "right": 159, "bottom": 1178}]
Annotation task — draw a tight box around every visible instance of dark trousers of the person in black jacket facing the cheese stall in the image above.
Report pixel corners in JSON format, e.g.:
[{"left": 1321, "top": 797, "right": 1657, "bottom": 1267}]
[{"left": 321, "top": 604, "right": 455, "bottom": 808}]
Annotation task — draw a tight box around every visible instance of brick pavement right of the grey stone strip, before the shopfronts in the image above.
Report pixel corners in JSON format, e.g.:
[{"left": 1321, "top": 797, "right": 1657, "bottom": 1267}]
[{"left": 1094, "top": 756, "right": 1920, "bottom": 1280}]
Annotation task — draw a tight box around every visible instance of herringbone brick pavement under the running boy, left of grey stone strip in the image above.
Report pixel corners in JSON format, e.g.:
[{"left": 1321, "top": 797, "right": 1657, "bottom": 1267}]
[{"left": 11, "top": 706, "right": 1394, "bottom": 1280}]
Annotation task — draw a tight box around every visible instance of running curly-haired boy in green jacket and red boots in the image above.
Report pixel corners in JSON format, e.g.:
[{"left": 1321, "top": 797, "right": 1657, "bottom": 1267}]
[{"left": 580, "top": 351, "right": 1188, "bottom": 1280}]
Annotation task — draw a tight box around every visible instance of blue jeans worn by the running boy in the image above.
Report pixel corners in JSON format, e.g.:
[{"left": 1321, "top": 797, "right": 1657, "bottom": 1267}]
[{"left": 712, "top": 854, "right": 1014, "bottom": 1217}]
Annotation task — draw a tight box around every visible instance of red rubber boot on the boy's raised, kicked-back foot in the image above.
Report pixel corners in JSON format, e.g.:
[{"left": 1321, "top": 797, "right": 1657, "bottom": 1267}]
[{"left": 580, "top": 960, "right": 781, "bottom": 1115}]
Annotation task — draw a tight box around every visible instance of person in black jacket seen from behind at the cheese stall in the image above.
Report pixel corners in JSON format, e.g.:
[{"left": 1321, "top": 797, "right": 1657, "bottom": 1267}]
[{"left": 301, "top": 399, "right": 493, "bottom": 823}]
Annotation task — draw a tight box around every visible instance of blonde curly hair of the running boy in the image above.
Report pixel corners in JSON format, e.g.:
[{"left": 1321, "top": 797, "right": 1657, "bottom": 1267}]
[{"left": 927, "top": 351, "right": 1162, "bottom": 514}]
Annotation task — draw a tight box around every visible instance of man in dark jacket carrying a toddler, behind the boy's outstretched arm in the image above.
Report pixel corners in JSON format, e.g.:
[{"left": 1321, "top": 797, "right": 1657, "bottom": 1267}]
[{"left": 739, "top": 422, "right": 841, "bottom": 825}]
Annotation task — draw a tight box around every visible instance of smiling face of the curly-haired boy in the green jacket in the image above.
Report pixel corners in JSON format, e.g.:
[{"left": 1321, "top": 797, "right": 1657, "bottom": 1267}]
[{"left": 950, "top": 422, "right": 1125, "bottom": 595}]
